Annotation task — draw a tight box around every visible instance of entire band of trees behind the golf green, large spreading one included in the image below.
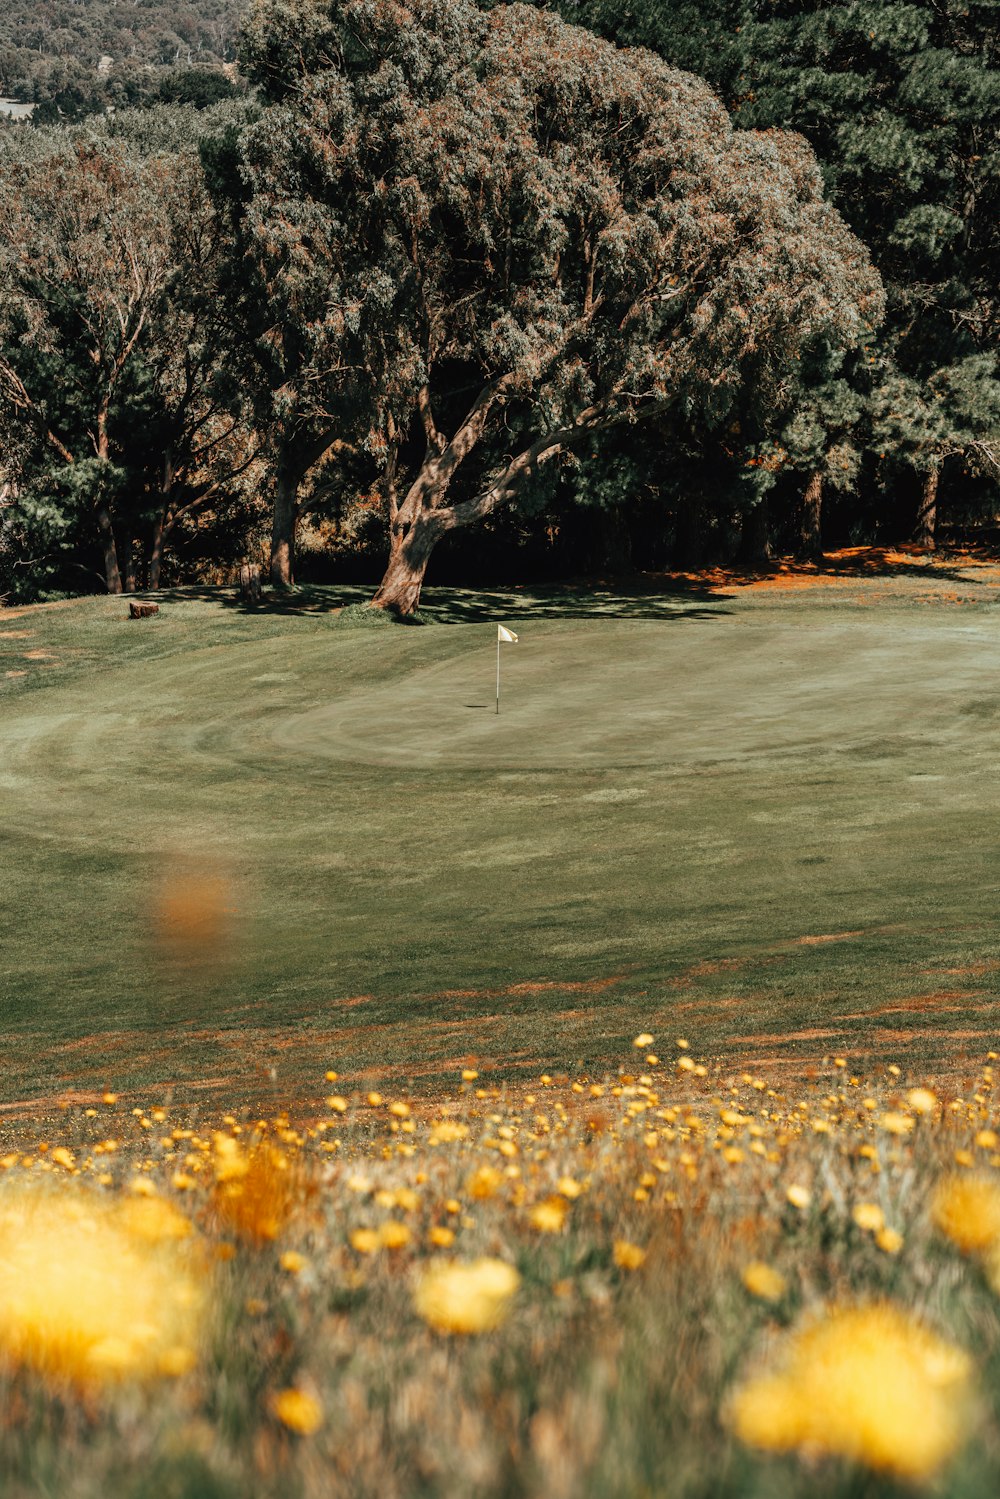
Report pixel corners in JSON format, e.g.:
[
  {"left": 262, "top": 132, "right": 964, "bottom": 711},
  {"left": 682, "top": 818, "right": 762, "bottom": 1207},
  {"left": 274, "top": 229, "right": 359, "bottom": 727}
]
[{"left": 0, "top": 0, "right": 1000, "bottom": 612}]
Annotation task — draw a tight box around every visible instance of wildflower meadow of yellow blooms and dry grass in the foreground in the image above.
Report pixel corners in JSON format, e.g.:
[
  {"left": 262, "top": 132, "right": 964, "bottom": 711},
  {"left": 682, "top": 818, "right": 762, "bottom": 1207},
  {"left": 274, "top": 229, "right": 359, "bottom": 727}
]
[{"left": 0, "top": 1033, "right": 1000, "bottom": 1499}]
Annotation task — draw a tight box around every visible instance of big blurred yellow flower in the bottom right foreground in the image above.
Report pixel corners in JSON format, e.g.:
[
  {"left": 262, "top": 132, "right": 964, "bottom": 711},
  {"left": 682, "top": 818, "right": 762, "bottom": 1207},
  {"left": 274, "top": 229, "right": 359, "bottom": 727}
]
[{"left": 727, "top": 1303, "right": 970, "bottom": 1480}]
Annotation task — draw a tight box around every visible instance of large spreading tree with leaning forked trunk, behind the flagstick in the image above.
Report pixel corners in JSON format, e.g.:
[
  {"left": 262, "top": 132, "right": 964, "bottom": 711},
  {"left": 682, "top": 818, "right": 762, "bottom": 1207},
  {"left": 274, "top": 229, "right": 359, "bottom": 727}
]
[{"left": 235, "top": 0, "right": 882, "bottom": 613}]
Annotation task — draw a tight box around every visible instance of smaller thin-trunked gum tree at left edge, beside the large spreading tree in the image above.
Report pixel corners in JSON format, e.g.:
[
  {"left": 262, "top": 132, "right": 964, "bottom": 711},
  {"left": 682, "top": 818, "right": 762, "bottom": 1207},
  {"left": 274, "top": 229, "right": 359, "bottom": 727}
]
[{"left": 0, "top": 111, "right": 260, "bottom": 592}]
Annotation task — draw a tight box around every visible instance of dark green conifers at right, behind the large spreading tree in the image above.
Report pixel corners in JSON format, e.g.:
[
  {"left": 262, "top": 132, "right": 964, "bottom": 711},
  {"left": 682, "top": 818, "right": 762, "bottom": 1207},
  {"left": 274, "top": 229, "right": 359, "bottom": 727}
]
[{"left": 548, "top": 0, "right": 1000, "bottom": 563}]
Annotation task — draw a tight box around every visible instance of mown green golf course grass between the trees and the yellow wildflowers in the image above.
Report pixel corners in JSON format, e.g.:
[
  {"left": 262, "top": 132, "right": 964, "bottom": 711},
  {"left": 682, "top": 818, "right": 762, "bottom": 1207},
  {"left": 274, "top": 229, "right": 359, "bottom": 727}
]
[{"left": 0, "top": 559, "right": 1000, "bottom": 1115}]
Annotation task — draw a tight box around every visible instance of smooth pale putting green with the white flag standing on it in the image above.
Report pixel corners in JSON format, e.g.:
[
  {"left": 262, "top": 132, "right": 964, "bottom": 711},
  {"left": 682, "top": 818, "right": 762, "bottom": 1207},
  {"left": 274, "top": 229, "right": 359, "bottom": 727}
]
[{"left": 273, "top": 612, "right": 1000, "bottom": 790}]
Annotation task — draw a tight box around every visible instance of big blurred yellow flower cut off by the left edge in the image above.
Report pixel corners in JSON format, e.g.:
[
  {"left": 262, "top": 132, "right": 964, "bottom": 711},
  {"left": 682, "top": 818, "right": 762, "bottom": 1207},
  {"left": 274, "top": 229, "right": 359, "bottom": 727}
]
[{"left": 0, "top": 1181, "right": 202, "bottom": 1385}]
